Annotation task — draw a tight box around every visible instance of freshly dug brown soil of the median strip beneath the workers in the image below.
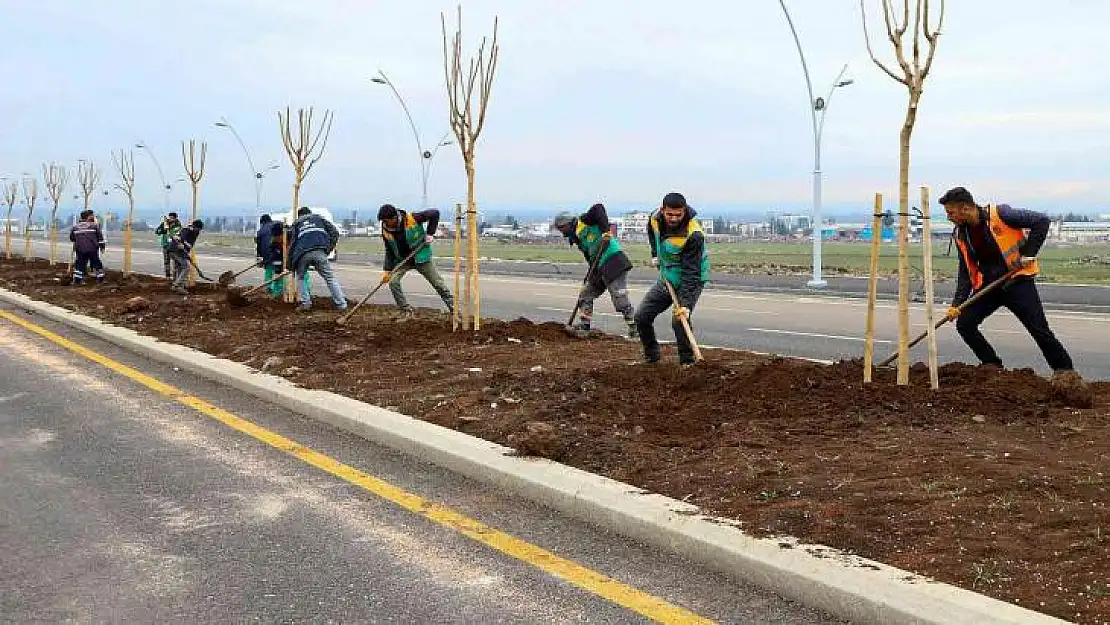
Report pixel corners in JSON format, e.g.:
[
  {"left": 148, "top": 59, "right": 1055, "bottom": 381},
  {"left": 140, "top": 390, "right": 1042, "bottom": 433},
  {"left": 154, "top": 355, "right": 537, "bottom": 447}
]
[{"left": 0, "top": 256, "right": 1110, "bottom": 623}]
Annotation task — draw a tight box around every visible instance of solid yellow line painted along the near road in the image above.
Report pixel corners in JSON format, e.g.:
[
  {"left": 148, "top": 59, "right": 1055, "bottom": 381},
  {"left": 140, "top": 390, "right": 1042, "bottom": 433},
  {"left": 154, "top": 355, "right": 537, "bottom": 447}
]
[{"left": 0, "top": 310, "right": 713, "bottom": 623}]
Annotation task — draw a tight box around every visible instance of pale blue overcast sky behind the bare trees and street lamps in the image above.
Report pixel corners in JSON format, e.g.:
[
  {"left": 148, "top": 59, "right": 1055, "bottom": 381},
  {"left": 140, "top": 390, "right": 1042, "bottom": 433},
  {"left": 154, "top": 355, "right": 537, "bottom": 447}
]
[{"left": 0, "top": 0, "right": 1110, "bottom": 215}]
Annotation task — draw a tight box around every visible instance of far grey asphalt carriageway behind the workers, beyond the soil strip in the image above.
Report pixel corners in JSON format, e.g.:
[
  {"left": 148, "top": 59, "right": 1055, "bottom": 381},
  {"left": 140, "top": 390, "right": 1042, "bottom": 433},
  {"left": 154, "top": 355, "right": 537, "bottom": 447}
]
[{"left": 21, "top": 238, "right": 1110, "bottom": 380}]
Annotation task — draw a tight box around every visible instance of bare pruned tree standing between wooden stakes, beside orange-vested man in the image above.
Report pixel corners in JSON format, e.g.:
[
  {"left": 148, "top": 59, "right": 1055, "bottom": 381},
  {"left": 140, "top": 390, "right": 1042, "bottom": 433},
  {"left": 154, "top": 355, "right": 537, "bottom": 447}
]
[{"left": 859, "top": 0, "right": 945, "bottom": 384}]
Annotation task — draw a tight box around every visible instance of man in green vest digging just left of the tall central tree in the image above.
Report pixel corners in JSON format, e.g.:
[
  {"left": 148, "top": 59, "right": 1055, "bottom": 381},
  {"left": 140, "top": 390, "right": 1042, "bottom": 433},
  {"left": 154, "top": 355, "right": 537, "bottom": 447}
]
[{"left": 377, "top": 204, "right": 455, "bottom": 316}]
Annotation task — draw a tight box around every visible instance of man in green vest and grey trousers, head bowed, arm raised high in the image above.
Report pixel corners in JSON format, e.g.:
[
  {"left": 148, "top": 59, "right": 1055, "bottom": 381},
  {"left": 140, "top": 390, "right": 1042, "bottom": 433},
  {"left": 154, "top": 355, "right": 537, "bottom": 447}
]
[{"left": 554, "top": 204, "right": 639, "bottom": 339}]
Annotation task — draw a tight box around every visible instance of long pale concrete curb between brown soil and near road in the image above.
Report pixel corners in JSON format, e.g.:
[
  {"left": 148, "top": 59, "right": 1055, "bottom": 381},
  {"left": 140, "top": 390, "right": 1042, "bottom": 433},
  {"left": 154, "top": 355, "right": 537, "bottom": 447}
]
[{"left": 0, "top": 289, "right": 1067, "bottom": 625}]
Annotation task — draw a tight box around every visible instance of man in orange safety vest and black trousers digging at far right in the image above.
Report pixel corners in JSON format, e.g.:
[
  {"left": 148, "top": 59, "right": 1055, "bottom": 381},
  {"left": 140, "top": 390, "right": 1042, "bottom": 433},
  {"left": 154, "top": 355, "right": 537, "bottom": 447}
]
[{"left": 939, "top": 187, "right": 1079, "bottom": 381}]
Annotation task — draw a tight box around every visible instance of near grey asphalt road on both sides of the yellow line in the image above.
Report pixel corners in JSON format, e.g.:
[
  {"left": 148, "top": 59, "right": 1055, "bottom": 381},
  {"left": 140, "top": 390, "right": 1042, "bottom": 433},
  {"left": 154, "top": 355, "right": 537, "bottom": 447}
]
[{"left": 0, "top": 309, "right": 835, "bottom": 625}]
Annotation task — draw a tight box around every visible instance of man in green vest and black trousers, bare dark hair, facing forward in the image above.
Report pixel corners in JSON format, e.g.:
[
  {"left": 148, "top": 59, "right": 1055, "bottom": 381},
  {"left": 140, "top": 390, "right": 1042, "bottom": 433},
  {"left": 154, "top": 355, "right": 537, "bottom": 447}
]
[{"left": 636, "top": 193, "right": 709, "bottom": 366}]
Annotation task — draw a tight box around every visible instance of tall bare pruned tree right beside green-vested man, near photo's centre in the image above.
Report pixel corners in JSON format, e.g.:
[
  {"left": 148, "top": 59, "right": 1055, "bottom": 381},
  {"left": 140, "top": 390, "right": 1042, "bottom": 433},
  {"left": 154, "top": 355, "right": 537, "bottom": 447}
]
[{"left": 440, "top": 6, "right": 501, "bottom": 330}]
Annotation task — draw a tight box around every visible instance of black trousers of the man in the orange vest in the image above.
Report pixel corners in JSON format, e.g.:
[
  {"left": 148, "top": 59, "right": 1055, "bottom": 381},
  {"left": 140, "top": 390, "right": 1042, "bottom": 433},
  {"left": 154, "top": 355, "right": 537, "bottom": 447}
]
[{"left": 956, "top": 278, "right": 1072, "bottom": 371}]
